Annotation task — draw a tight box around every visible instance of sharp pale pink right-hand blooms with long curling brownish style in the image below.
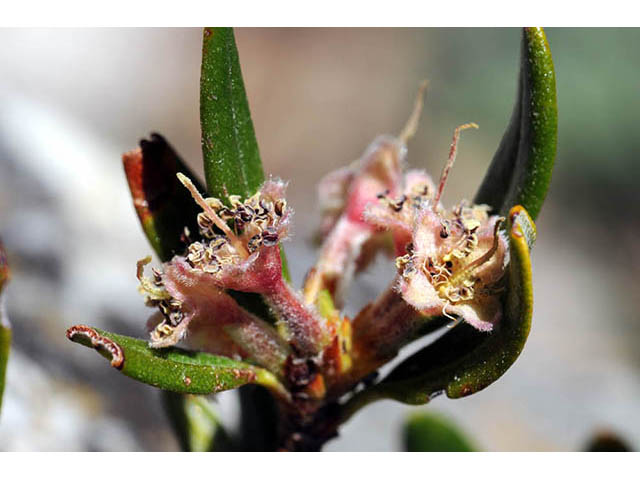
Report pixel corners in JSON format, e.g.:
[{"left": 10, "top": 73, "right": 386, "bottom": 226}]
[{"left": 365, "top": 124, "right": 507, "bottom": 331}]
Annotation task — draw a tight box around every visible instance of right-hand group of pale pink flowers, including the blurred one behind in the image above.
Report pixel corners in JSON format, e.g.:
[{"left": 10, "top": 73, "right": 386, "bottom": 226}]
[{"left": 313, "top": 117, "right": 507, "bottom": 331}]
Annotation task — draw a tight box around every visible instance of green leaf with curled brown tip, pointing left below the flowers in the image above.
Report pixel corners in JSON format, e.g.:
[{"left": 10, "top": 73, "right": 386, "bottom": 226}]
[{"left": 67, "top": 325, "right": 286, "bottom": 395}]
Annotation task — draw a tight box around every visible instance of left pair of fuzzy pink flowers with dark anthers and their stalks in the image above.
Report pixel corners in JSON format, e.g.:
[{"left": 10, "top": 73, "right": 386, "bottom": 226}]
[{"left": 138, "top": 173, "right": 333, "bottom": 360}]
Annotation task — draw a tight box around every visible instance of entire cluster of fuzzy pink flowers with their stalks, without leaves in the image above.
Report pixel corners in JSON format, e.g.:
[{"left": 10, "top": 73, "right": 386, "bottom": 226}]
[{"left": 138, "top": 84, "right": 508, "bottom": 396}]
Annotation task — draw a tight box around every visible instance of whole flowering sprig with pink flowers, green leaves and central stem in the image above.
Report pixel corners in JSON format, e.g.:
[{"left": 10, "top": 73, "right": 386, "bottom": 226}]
[{"left": 62, "top": 29, "right": 556, "bottom": 450}]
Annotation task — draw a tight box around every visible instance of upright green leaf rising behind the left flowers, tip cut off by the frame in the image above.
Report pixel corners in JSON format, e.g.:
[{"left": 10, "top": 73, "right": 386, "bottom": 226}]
[{"left": 200, "top": 28, "right": 264, "bottom": 199}]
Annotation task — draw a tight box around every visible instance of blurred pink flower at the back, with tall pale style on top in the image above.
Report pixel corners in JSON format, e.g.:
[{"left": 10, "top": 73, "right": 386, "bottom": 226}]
[{"left": 305, "top": 82, "right": 427, "bottom": 306}]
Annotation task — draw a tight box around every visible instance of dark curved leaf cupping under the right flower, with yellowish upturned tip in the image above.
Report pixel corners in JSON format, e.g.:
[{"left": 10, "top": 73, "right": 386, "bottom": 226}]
[{"left": 344, "top": 206, "right": 535, "bottom": 412}]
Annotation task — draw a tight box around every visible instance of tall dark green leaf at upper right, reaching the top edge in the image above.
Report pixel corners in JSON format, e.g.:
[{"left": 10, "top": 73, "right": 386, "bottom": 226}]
[{"left": 474, "top": 28, "right": 558, "bottom": 220}]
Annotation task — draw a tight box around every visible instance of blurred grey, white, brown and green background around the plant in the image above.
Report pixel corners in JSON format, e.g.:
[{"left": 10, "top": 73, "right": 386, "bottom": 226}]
[{"left": 0, "top": 28, "right": 640, "bottom": 451}]
